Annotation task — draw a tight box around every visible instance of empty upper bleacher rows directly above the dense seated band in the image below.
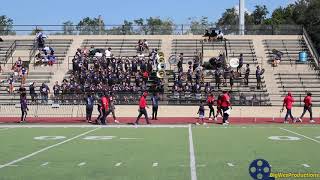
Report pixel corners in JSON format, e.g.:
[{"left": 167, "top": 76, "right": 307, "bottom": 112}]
[{"left": 82, "top": 39, "right": 161, "bottom": 57}]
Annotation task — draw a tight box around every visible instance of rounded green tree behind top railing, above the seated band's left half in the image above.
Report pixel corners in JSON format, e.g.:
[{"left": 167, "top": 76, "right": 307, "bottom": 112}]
[{"left": 77, "top": 16, "right": 105, "bottom": 35}]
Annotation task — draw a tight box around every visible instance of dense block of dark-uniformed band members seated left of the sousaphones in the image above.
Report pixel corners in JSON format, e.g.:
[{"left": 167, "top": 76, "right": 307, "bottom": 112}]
[{"left": 55, "top": 46, "right": 164, "bottom": 103}]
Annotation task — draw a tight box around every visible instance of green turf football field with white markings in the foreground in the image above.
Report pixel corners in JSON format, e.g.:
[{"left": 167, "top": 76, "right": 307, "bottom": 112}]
[{"left": 0, "top": 124, "right": 320, "bottom": 180}]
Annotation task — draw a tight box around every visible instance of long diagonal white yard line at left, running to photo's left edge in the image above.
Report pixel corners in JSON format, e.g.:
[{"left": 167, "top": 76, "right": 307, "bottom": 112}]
[{"left": 0, "top": 127, "right": 100, "bottom": 169}]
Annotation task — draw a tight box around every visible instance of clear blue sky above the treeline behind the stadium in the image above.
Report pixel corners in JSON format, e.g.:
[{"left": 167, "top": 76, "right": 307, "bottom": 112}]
[{"left": 0, "top": 0, "right": 294, "bottom": 25}]
